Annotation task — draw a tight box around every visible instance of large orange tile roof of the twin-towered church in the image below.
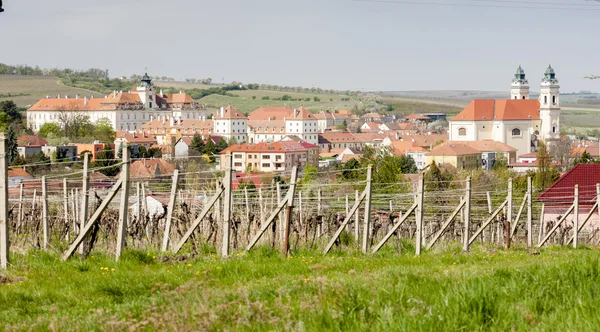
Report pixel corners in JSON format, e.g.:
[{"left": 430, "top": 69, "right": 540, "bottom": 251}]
[{"left": 452, "top": 99, "right": 540, "bottom": 121}]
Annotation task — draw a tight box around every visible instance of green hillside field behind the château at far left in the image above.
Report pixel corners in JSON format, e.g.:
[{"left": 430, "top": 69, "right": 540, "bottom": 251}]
[{"left": 0, "top": 75, "right": 101, "bottom": 107}]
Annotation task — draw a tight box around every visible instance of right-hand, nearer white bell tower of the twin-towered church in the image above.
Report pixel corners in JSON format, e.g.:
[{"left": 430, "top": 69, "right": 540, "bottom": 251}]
[{"left": 540, "top": 65, "right": 560, "bottom": 140}]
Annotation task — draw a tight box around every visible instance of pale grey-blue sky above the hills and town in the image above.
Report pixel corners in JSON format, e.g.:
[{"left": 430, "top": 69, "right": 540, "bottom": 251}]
[{"left": 0, "top": 0, "right": 600, "bottom": 92}]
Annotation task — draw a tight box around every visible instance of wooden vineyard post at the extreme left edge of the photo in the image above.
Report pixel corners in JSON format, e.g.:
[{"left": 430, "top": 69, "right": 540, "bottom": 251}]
[{"left": 0, "top": 133, "right": 10, "bottom": 270}]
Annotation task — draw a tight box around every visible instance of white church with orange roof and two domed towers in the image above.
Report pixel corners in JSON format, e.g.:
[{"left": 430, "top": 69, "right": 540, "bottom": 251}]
[{"left": 449, "top": 66, "right": 560, "bottom": 158}]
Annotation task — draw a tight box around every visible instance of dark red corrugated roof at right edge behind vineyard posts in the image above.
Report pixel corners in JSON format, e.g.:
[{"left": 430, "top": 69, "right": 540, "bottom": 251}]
[{"left": 537, "top": 164, "right": 600, "bottom": 204}]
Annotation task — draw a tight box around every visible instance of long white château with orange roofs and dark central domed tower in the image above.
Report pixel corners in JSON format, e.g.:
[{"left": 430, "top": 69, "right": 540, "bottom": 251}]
[{"left": 27, "top": 74, "right": 205, "bottom": 131}]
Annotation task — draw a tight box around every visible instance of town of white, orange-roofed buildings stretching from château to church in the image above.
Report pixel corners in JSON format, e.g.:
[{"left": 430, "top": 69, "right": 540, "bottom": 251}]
[{"left": 11, "top": 66, "right": 600, "bottom": 185}]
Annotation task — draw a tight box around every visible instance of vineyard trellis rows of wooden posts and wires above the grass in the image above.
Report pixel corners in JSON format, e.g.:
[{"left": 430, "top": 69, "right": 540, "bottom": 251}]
[{"left": 0, "top": 134, "right": 600, "bottom": 268}]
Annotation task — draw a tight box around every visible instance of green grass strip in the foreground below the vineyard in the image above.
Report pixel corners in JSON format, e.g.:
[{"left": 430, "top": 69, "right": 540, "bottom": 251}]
[{"left": 0, "top": 246, "right": 600, "bottom": 331}]
